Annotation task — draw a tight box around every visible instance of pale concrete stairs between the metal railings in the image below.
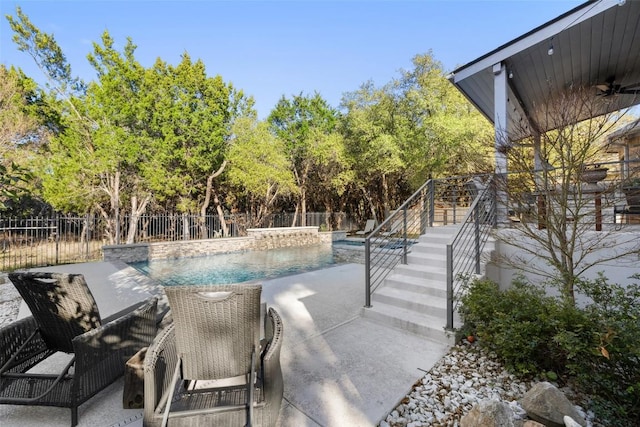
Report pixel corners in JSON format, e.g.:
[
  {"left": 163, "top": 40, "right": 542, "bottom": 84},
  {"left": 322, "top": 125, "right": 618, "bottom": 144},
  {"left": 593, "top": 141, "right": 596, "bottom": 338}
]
[{"left": 363, "top": 225, "right": 492, "bottom": 345}]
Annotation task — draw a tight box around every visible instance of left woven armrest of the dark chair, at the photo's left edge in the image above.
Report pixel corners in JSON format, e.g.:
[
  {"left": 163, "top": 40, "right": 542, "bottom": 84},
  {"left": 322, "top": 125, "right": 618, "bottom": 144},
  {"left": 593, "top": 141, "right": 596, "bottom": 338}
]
[{"left": 0, "top": 316, "right": 52, "bottom": 372}]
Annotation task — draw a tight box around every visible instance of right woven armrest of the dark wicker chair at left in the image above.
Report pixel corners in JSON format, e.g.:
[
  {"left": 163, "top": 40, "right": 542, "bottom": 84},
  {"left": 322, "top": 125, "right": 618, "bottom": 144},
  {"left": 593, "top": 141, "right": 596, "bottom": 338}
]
[{"left": 73, "top": 298, "right": 158, "bottom": 402}]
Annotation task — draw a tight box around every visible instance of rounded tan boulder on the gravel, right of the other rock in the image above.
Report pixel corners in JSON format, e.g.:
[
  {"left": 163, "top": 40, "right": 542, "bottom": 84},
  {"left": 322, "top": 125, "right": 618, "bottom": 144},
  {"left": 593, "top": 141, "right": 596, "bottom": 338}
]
[{"left": 521, "top": 381, "right": 586, "bottom": 427}]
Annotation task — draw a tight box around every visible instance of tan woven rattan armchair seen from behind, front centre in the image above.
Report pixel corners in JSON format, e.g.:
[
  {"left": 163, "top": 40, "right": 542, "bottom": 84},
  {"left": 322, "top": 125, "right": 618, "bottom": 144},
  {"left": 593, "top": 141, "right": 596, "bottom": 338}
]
[{"left": 143, "top": 284, "right": 283, "bottom": 427}]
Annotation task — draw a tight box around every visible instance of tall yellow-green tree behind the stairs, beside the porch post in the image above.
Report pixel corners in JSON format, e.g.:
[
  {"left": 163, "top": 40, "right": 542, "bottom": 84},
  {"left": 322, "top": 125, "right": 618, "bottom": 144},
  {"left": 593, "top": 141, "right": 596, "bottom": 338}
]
[{"left": 342, "top": 52, "right": 492, "bottom": 222}]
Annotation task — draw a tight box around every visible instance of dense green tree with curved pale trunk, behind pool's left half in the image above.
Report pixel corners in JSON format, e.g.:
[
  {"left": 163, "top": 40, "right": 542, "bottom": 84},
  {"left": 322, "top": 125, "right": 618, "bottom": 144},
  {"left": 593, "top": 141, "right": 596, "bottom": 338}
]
[{"left": 144, "top": 53, "right": 255, "bottom": 238}]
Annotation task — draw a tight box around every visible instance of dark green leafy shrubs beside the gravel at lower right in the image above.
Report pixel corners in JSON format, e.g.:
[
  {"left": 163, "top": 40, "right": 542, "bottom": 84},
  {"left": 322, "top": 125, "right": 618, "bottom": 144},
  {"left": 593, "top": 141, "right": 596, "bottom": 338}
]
[{"left": 461, "top": 276, "right": 640, "bottom": 425}]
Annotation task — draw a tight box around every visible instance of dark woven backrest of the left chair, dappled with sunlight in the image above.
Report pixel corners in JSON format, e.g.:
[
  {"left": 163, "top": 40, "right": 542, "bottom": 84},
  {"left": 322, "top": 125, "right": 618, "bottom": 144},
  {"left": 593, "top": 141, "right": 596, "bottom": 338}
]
[{"left": 9, "top": 272, "right": 101, "bottom": 353}]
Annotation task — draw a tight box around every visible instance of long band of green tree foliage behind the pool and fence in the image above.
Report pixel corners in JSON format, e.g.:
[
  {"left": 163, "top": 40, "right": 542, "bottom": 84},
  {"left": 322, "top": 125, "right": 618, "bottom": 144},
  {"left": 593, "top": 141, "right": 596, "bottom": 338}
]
[{"left": 6, "top": 8, "right": 492, "bottom": 226}]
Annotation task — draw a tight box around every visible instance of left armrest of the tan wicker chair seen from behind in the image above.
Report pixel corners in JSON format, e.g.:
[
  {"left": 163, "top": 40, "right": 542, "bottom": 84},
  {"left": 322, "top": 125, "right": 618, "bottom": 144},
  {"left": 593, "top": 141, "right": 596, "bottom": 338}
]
[{"left": 144, "top": 323, "right": 178, "bottom": 425}]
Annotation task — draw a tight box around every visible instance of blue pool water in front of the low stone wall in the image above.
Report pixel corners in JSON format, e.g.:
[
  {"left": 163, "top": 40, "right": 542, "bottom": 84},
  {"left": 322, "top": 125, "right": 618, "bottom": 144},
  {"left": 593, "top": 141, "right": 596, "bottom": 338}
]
[{"left": 126, "top": 245, "right": 336, "bottom": 286}]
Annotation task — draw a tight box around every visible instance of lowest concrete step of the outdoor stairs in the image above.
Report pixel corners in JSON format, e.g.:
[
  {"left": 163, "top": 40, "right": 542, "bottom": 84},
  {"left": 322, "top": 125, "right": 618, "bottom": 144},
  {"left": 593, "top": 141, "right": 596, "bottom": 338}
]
[{"left": 362, "top": 302, "right": 455, "bottom": 346}]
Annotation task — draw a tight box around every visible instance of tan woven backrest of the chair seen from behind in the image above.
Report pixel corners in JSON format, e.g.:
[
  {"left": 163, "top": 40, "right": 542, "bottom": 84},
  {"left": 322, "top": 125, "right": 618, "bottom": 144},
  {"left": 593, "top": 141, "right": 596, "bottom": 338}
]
[{"left": 164, "top": 284, "right": 262, "bottom": 380}]
